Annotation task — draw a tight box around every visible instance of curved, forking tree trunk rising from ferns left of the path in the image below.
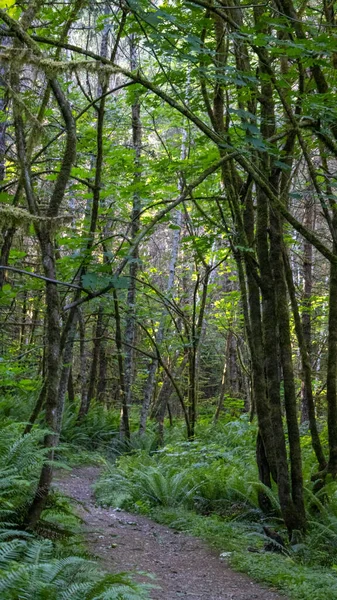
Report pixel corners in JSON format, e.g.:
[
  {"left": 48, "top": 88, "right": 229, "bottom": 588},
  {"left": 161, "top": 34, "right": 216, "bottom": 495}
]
[{"left": 12, "top": 8, "right": 77, "bottom": 528}]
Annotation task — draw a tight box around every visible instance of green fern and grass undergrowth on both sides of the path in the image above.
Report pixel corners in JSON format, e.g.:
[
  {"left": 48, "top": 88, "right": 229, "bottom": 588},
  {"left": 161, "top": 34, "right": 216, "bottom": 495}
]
[{"left": 0, "top": 400, "right": 337, "bottom": 600}]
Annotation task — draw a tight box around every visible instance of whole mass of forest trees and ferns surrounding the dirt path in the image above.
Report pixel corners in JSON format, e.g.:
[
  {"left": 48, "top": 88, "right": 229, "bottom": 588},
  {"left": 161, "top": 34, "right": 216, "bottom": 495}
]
[{"left": 0, "top": 0, "right": 337, "bottom": 598}]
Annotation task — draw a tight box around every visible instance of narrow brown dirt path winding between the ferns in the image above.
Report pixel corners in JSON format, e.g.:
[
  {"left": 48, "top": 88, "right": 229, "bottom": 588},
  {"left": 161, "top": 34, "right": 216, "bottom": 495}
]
[{"left": 56, "top": 467, "right": 286, "bottom": 600}]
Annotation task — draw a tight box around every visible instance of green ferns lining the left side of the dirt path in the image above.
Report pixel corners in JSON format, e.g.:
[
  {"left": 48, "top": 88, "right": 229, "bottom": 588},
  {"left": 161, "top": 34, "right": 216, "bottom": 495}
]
[{"left": 0, "top": 423, "right": 149, "bottom": 600}]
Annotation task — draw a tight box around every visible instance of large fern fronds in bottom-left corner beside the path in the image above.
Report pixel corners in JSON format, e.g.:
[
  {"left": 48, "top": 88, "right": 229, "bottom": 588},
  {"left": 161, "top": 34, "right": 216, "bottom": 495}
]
[{"left": 0, "top": 539, "right": 148, "bottom": 600}]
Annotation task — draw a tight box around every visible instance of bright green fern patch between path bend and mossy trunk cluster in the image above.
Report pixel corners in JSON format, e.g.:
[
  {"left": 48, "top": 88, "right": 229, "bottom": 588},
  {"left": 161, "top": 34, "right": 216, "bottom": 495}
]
[{"left": 96, "top": 418, "right": 260, "bottom": 519}]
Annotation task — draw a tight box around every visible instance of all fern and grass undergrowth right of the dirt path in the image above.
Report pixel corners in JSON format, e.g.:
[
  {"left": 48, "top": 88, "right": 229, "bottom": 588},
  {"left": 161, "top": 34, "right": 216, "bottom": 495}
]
[{"left": 95, "top": 416, "right": 337, "bottom": 600}]
